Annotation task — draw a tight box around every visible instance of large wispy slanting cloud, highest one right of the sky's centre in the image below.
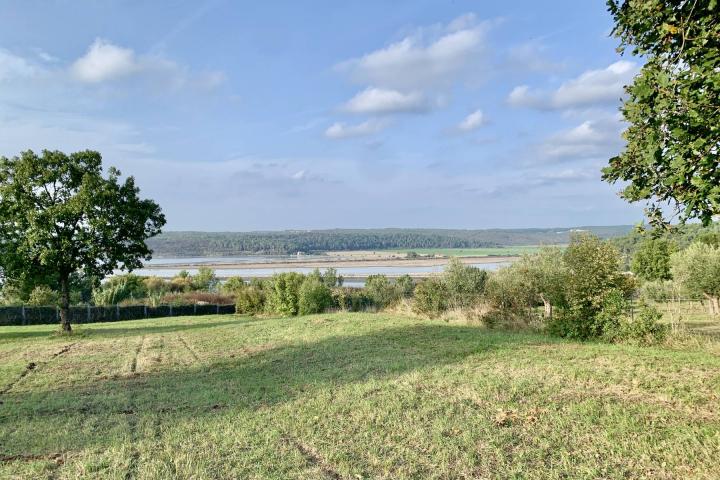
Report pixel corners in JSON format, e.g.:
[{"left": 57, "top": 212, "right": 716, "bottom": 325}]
[{"left": 337, "top": 15, "right": 489, "bottom": 89}]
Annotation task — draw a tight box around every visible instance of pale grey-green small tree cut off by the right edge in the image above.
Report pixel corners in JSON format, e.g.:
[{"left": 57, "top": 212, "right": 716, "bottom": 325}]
[{"left": 671, "top": 242, "right": 720, "bottom": 315}]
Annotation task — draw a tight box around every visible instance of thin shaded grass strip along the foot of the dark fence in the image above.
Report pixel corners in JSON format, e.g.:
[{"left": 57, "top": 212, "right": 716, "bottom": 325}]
[{"left": 0, "top": 315, "right": 265, "bottom": 341}]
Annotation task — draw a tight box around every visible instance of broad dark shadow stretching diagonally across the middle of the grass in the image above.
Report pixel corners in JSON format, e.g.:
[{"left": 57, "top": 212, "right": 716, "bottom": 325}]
[{"left": 0, "top": 320, "right": 549, "bottom": 454}]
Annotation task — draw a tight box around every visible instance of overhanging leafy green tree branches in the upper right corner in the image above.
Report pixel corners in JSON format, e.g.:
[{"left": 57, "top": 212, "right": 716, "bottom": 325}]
[{"left": 603, "top": 0, "right": 720, "bottom": 226}]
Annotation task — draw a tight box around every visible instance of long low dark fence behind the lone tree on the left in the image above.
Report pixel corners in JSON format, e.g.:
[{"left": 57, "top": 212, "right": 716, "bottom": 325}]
[{"left": 0, "top": 304, "right": 235, "bottom": 325}]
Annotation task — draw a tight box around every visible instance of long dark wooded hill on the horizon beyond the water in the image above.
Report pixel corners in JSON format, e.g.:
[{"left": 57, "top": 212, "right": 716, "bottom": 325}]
[{"left": 148, "top": 225, "right": 633, "bottom": 257}]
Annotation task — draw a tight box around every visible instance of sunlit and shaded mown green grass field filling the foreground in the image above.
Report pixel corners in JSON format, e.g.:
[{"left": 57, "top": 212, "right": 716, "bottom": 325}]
[{"left": 0, "top": 314, "right": 720, "bottom": 479}]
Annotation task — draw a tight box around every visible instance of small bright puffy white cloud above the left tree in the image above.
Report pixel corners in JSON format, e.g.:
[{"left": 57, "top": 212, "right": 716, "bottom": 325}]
[{"left": 71, "top": 38, "right": 143, "bottom": 83}]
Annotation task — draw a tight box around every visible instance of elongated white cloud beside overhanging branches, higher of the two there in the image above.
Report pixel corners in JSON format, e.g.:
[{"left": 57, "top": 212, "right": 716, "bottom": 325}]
[{"left": 508, "top": 60, "right": 639, "bottom": 110}]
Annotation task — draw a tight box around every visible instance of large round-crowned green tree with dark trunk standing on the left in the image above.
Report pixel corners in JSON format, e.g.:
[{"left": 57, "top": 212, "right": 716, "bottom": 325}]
[{"left": 0, "top": 150, "right": 165, "bottom": 332}]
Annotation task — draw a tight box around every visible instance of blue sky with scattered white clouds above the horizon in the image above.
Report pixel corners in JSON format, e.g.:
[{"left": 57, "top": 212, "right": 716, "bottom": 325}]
[{"left": 0, "top": 0, "right": 642, "bottom": 230}]
